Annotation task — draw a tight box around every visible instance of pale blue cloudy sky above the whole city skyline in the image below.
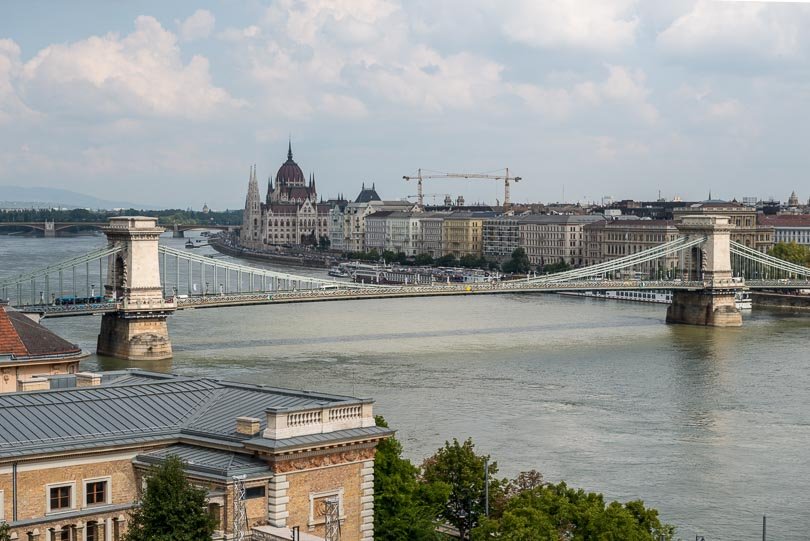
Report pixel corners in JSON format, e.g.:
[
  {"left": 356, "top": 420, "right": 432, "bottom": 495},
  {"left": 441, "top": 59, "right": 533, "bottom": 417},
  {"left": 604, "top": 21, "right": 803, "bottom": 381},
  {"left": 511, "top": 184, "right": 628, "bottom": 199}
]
[{"left": 0, "top": 0, "right": 810, "bottom": 209}]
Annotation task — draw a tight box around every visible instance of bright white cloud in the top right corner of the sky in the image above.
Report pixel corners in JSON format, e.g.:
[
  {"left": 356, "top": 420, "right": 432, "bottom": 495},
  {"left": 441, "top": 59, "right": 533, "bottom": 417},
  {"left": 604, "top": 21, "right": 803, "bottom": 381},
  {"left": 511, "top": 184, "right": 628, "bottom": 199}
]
[{"left": 657, "top": 0, "right": 810, "bottom": 59}]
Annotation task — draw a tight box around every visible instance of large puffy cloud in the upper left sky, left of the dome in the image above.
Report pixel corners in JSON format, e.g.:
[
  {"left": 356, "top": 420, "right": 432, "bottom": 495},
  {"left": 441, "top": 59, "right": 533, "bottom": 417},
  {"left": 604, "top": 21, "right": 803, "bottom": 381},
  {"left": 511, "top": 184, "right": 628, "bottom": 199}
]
[{"left": 20, "top": 16, "right": 241, "bottom": 119}]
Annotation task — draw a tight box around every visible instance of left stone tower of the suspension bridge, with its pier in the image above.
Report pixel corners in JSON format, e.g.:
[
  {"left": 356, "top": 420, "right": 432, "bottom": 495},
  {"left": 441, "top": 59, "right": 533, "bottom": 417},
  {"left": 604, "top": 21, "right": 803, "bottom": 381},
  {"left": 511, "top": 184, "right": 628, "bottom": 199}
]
[{"left": 97, "top": 216, "right": 177, "bottom": 360}]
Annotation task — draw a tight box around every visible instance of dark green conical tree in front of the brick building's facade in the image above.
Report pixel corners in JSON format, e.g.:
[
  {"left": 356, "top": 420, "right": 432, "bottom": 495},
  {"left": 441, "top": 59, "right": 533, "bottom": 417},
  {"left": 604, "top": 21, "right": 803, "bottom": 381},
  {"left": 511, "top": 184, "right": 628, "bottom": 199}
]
[{"left": 125, "top": 456, "right": 215, "bottom": 541}]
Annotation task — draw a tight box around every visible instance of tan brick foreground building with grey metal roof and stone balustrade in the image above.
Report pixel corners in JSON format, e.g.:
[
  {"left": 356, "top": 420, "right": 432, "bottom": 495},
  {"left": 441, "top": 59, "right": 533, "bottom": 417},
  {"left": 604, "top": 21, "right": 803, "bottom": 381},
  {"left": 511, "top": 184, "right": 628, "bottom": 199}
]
[{"left": 0, "top": 370, "right": 393, "bottom": 541}]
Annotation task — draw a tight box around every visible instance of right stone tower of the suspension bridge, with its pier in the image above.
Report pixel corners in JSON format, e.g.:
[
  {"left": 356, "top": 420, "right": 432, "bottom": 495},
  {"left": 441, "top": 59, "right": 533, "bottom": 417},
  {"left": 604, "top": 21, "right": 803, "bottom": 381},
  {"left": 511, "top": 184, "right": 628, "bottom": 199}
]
[{"left": 667, "top": 216, "right": 742, "bottom": 327}]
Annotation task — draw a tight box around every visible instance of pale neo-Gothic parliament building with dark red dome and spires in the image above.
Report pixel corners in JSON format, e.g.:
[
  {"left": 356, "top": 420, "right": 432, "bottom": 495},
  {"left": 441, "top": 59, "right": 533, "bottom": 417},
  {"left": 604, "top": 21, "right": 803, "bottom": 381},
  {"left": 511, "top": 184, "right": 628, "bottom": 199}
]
[{"left": 239, "top": 143, "right": 329, "bottom": 250}]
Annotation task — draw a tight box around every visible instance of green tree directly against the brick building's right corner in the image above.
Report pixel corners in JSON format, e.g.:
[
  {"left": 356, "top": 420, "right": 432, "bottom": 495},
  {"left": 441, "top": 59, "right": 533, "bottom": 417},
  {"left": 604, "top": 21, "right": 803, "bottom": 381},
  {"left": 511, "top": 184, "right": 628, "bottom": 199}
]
[{"left": 374, "top": 415, "right": 446, "bottom": 541}]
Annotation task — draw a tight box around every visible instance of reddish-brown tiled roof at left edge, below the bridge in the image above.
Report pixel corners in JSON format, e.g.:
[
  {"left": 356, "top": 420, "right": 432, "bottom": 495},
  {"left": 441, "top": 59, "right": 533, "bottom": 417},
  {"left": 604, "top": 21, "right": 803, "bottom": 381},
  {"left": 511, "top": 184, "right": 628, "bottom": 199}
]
[{"left": 0, "top": 304, "right": 83, "bottom": 360}]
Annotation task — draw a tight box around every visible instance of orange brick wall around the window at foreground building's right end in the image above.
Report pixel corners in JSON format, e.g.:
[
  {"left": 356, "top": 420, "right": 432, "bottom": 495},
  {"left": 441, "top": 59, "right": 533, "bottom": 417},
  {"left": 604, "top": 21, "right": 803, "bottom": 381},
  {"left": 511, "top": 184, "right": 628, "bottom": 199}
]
[{"left": 280, "top": 462, "right": 363, "bottom": 541}]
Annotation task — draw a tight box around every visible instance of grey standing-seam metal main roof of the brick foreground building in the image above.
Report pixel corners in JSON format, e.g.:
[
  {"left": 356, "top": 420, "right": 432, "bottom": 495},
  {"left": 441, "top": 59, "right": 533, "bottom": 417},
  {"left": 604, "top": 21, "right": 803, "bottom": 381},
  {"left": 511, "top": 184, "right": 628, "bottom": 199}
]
[{"left": 0, "top": 371, "right": 376, "bottom": 458}]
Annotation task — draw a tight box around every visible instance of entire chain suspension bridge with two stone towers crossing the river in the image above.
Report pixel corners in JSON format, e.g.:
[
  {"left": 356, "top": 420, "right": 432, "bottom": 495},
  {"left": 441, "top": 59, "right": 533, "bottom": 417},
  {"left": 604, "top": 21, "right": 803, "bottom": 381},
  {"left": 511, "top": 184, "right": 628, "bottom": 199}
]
[{"left": 0, "top": 216, "right": 810, "bottom": 360}]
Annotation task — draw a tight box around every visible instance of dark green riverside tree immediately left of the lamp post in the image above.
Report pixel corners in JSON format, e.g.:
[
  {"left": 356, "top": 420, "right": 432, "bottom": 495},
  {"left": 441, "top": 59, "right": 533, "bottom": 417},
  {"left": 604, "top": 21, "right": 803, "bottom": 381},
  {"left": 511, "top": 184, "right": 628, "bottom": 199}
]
[{"left": 422, "top": 438, "right": 500, "bottom": 540}]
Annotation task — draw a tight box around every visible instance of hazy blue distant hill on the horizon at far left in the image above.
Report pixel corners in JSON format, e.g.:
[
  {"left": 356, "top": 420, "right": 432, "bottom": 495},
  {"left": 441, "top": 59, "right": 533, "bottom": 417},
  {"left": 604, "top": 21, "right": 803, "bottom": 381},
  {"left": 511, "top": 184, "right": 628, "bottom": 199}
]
[{"left": 0, "top": 186, "right": 161, "bottom": 210}]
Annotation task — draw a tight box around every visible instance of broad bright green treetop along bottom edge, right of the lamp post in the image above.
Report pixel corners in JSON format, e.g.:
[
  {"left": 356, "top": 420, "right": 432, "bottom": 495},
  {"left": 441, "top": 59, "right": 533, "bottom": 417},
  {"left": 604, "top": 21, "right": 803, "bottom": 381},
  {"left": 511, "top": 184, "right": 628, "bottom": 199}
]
[{"left": 472, "top": 483, "right": 674, "bottom": 541}]
